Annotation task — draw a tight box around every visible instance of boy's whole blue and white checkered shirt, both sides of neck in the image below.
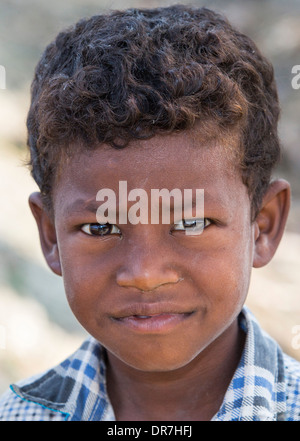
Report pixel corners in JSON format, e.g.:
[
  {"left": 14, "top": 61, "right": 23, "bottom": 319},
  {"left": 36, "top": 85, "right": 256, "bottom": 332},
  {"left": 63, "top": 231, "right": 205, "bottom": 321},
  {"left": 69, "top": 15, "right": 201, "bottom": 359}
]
[{"left": 0, "top": 308, "right": 300, "bottom": 421}]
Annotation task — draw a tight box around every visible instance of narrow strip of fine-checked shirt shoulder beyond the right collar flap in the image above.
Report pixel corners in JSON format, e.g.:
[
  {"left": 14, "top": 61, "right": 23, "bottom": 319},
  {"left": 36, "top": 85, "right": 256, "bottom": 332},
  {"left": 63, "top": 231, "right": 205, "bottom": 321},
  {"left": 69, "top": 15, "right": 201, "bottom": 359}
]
[{"left": 284, "top": 354, "right": 300, "bottom": 421}]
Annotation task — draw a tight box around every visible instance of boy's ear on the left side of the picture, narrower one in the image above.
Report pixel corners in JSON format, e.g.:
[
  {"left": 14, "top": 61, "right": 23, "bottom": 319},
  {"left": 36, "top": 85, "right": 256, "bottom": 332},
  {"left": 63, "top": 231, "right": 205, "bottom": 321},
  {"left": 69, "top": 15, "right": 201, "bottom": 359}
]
[{"left": 29, "top": 192, "right": 62, "bottom": 276}]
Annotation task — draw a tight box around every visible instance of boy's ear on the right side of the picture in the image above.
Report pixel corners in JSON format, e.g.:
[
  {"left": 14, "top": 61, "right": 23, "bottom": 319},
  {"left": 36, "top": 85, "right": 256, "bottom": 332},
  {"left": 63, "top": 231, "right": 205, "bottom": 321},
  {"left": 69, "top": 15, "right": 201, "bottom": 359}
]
[{"left": 253, "top": 179, "right": 291, "bottom": 268}]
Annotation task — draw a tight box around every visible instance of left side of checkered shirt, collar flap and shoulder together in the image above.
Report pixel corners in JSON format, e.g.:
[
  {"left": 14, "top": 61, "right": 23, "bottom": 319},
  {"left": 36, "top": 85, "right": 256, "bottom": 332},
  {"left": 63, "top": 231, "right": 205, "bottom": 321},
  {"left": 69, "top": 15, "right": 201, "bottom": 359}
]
[{"left": 0, "top": 337, "right": 109, "bottom": 421}]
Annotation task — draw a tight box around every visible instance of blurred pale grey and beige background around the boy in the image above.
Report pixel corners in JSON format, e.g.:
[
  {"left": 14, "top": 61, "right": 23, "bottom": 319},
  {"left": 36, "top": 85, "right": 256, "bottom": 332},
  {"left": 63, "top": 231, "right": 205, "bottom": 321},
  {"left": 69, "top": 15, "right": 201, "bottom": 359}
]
[{"left": 0, "top": 0, "right": 300, "bottom": 393}]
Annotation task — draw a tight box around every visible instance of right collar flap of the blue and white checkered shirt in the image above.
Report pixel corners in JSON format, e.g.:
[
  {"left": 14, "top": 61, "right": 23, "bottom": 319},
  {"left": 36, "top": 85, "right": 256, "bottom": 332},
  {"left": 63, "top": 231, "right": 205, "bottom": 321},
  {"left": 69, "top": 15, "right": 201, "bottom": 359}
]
[{"left": 213, "top": 307, "right": 286, "bottom": 421}]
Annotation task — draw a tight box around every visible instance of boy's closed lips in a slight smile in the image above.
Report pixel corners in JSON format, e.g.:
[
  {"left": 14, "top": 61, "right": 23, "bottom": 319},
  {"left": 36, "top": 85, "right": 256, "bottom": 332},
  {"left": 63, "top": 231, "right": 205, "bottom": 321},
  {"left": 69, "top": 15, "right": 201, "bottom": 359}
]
[{"left": 111, "top": 303, "right": 194, "bottom": 333}]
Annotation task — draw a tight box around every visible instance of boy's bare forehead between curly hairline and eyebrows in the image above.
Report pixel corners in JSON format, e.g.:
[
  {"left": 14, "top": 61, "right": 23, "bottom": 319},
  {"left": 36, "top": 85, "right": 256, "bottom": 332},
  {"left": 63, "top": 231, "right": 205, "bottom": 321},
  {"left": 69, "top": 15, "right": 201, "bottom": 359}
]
[{"left": 63, "top": 130, "right": 239, "bottom": 184}]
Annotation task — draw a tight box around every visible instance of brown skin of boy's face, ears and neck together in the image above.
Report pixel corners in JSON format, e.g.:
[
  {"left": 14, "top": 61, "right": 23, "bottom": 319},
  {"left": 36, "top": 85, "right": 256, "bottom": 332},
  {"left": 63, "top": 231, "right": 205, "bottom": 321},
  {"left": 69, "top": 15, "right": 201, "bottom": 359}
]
[{"left": 30, "top": 129, "right": 290, "bottom": 421}]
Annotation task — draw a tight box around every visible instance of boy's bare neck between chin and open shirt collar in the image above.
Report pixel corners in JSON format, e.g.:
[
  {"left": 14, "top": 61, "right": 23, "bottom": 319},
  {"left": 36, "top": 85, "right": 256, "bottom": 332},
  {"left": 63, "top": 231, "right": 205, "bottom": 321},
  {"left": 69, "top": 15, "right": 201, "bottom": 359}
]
[{"left": 107, "top": 321, "right": 245, "bottom": 421}]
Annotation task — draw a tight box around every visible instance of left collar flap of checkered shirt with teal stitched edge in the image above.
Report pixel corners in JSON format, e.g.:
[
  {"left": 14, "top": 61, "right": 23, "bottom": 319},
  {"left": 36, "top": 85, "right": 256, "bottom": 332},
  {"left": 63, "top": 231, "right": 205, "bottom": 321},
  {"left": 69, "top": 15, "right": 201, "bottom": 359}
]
[{"left": 12, "top": 337, "right": 115, "bottom": 421}]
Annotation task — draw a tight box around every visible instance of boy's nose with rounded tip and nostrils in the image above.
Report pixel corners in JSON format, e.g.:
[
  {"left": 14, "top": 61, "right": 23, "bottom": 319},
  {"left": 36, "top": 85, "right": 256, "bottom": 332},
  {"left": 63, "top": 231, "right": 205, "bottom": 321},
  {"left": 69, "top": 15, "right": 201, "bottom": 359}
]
[{"left": 116, "top": 235, "right": 183, "bottom": 291}]
